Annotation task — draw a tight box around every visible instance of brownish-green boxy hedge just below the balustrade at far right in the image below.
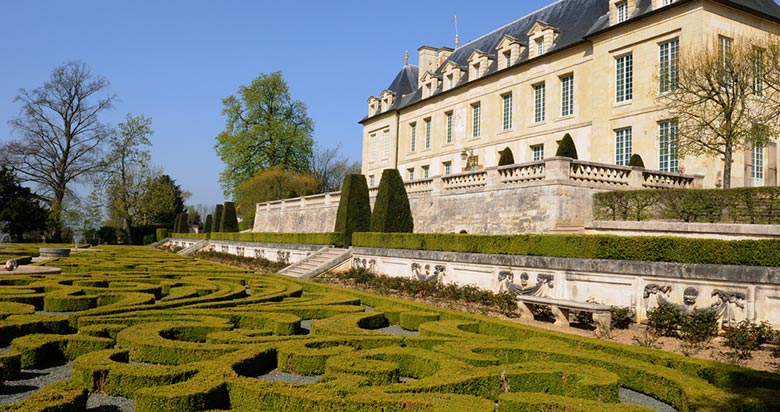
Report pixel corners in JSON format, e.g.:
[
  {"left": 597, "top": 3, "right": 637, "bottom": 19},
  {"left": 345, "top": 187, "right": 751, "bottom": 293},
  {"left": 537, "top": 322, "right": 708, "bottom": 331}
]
[{"left": 593, "top": 187, "right": 780, "bottom": 224}]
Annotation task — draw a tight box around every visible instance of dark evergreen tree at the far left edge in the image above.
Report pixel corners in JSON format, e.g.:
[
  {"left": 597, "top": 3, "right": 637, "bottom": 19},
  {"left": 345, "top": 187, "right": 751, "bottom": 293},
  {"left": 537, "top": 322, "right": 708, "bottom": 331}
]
[{"left": 0, "top": 166, "right": 48, "bottom": 241}]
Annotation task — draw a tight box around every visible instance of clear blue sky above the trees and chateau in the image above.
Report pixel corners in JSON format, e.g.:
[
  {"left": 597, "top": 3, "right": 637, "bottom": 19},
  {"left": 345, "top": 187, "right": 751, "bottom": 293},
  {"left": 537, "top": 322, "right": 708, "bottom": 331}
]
[{"left": 0, "top": 0, "right": 552, "bottom": 204}]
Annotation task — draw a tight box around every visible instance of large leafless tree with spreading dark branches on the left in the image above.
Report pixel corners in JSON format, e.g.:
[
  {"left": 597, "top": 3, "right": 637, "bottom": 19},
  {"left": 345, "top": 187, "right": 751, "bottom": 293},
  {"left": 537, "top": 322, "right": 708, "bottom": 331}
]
[{"left": 0, "top": 62, "right": 116, "bottom": 237}]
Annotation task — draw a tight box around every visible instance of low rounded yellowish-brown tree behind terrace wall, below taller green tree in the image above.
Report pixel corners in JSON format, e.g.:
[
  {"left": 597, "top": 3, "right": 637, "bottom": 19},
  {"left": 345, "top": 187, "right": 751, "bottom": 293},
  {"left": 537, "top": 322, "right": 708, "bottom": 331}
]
[{"left": 236, "top": 167, "right": 320, "bottom": 224}]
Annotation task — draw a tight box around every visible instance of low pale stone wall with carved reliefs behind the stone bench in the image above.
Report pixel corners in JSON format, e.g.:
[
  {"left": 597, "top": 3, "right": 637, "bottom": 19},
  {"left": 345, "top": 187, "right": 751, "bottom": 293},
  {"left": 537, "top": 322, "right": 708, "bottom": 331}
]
[{"left": 352, "top": 247, "right": 780, "bottom": 328}]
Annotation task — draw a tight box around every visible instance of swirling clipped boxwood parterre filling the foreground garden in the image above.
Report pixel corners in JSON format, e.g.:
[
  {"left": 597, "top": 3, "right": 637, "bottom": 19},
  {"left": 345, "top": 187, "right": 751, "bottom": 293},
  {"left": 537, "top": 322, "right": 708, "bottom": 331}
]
[{"left": 0, "top": 247, "right": 780, "bottom": 412}]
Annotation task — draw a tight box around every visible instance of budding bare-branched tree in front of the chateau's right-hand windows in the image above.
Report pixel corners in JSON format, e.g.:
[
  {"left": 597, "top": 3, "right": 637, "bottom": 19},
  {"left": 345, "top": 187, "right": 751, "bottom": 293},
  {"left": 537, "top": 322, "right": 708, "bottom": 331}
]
[{"left": 658, "top": 36, "right": 780, "bottom": 188}]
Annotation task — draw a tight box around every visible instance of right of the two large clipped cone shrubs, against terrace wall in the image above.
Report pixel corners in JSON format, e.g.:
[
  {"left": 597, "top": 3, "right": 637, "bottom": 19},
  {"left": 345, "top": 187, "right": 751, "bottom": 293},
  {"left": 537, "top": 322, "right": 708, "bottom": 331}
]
[{"left": 371, "top": 169, "right": 414, "bottom": 233}]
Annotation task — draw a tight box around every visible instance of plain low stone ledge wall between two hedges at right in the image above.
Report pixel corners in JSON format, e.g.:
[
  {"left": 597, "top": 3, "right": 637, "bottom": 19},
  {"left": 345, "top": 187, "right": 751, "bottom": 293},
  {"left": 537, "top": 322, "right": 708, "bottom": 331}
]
[{"left": 585, "top": 220, "right": 780, "bottom": 240}]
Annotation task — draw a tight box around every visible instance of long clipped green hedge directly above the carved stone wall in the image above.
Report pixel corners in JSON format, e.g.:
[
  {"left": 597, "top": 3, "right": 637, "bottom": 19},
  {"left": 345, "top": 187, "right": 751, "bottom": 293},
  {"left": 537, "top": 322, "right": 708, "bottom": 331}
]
[{"left": 353, "top": 233, "right": 780, "bottom": 266}]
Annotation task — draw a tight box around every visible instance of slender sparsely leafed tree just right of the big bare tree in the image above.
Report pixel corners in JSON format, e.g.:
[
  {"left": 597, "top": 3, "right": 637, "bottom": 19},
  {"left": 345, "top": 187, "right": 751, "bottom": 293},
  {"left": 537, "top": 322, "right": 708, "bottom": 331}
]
[{"left": 106, "top": 113, "right": 153, "bottom": 243}]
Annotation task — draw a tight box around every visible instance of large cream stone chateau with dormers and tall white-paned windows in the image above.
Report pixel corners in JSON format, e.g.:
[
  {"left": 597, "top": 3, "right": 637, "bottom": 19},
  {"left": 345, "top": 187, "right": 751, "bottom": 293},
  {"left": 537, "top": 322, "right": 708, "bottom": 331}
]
[{"left": 360, "top": 0, "right": 780, "bottom": 191}]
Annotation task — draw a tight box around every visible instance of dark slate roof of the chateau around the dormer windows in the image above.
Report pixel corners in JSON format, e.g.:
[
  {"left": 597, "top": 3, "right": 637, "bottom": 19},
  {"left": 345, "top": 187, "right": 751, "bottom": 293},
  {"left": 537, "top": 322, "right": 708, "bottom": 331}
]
[{"left": 361, "top": 0, "right": 780, "bottom": 122}]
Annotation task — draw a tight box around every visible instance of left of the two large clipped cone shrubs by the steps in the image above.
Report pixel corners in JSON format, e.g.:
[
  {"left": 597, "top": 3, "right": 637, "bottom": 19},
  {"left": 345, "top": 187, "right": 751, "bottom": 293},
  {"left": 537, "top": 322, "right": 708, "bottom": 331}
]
[{"left": 335, "top": 174, "right": 371, "bottom": 246}]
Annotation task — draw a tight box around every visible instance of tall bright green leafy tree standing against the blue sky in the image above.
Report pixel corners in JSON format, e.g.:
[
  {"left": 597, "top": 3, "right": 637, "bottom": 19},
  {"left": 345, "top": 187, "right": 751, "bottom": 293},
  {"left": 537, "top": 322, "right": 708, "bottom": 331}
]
[{"left": 214, "top": 71, "right": 314, "bottom": 197}]
